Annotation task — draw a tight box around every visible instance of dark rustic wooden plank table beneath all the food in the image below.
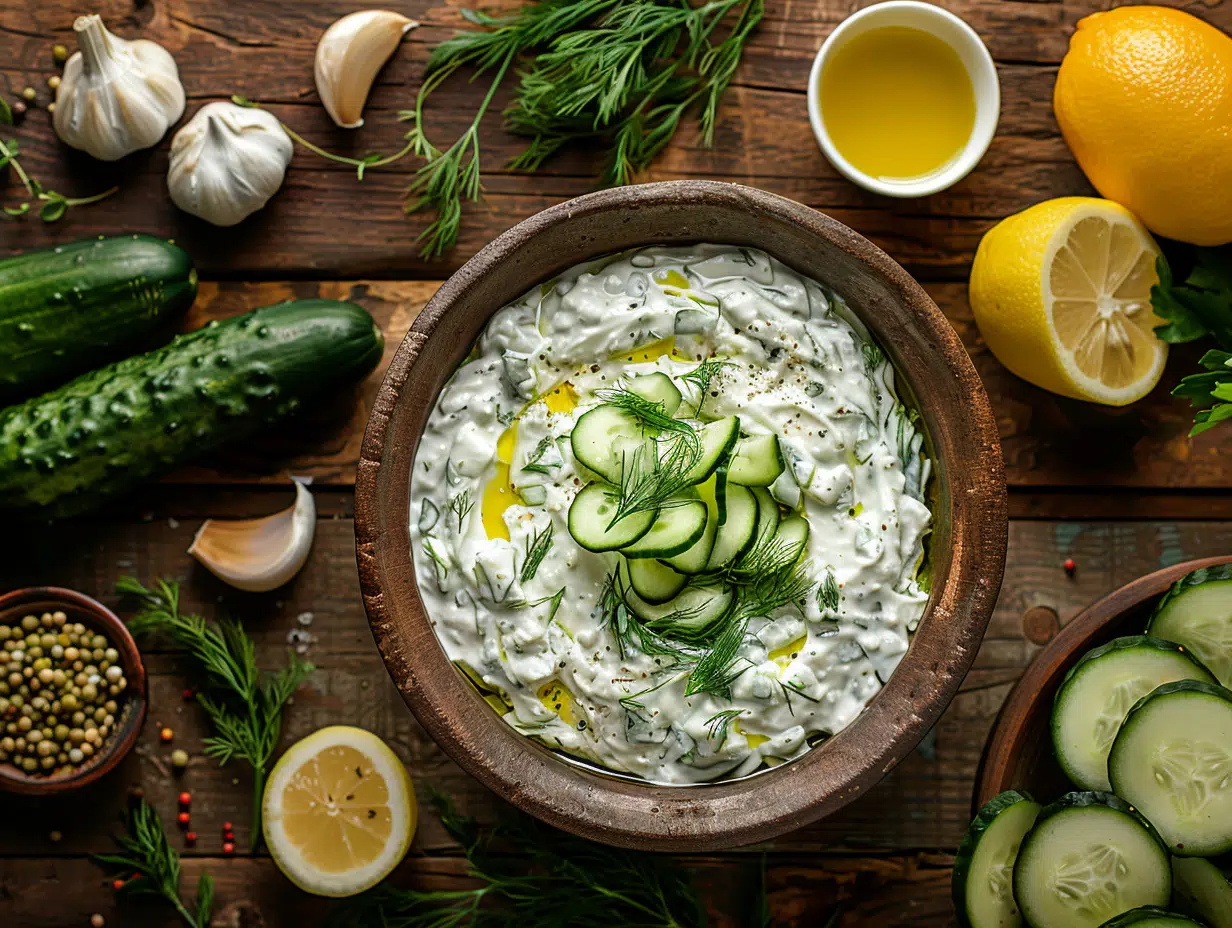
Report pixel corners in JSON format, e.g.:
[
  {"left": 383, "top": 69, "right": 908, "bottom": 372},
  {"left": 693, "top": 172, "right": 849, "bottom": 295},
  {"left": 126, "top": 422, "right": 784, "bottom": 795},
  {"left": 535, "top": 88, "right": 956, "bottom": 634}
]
[{"left": 0, "top": 0, "right": 1232, "bottom": 928}]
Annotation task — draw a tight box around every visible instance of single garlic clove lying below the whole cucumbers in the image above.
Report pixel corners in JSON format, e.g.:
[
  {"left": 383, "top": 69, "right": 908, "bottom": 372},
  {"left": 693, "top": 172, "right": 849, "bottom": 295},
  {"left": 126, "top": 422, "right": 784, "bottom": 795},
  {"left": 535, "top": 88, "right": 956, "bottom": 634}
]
[{"left": 188, "top": 481, "right": 317, "bottom": 593}]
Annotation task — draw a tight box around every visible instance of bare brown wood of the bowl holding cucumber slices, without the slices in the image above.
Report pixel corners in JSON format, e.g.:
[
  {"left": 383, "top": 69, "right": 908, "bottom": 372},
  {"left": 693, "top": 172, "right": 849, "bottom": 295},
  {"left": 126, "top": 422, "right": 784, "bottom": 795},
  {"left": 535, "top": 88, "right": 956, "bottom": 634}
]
[{"left": 972, "top": 556, "right": 1232, "bottom": 812}]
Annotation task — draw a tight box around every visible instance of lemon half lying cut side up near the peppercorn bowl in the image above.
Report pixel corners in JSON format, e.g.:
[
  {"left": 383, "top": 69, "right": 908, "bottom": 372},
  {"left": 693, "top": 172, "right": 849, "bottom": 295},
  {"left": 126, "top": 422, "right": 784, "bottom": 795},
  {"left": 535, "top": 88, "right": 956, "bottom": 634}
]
[{"left": 261, "top": 725, "right": 416, "bottom": 896}]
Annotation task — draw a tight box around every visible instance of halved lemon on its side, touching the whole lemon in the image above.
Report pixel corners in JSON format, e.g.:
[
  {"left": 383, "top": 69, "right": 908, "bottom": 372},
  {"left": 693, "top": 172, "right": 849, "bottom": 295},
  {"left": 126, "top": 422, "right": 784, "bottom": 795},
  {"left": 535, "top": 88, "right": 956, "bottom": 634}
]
[{"left": 971, "top": 197, "right": 1168, "bottom": 405}]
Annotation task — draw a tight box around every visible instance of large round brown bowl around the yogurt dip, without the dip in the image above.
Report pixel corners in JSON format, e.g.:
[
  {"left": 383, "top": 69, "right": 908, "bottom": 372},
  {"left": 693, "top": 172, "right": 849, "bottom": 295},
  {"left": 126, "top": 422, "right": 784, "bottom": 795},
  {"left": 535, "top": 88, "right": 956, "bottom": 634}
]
[{"left": 355, "top": 181, "right": 1007, "bottom": 852}]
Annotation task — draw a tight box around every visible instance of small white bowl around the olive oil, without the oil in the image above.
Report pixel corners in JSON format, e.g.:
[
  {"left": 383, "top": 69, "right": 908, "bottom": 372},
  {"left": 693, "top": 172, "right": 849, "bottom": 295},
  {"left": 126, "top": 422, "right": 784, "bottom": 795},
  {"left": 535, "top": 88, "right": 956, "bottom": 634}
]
[{"left": 808, "top": 0, "right": 1000, "bottom": 197}]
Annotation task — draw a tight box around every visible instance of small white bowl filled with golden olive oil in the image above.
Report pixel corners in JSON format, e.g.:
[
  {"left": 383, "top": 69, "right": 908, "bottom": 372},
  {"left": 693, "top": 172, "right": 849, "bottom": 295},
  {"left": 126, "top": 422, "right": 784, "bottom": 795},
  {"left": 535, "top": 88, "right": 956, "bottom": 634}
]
[{"left": 808, "top": 0, "right": 1000, "bottom": 196}]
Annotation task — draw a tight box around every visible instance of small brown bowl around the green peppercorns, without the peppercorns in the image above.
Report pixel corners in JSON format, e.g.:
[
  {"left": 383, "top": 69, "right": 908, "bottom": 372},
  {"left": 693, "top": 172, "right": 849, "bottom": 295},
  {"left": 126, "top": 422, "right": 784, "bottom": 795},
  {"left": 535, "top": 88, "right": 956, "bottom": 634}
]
[{"left": 0, "top": 587, "right": 147, "bottom": 796}]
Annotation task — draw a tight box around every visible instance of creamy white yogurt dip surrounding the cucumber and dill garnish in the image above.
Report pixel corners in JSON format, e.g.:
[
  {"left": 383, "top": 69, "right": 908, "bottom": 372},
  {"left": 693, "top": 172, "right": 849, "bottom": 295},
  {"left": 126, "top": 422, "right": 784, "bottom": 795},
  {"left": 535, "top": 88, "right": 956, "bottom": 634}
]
[{"left": 410, "top": 245, "right": 930, "bottom": 784}]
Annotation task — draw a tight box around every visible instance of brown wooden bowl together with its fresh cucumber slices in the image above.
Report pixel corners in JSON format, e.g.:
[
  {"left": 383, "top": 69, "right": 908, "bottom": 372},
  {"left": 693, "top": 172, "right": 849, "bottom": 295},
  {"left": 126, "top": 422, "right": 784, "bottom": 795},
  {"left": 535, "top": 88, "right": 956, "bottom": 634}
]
[{"left": 954, "top": 557, "right": 1232, "bottom": 928}]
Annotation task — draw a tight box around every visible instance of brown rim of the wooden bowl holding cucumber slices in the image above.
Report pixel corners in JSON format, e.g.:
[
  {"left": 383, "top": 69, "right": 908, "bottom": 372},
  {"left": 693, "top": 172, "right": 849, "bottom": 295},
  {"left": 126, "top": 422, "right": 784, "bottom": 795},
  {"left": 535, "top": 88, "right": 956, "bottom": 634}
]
[{"left": 972, "top": 555, "right": 1232, "bottom": 813}]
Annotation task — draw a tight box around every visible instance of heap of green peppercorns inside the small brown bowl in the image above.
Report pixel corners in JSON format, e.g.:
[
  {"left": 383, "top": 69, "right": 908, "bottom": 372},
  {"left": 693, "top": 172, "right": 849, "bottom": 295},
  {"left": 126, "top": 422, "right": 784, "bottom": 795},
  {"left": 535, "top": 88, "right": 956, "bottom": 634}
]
[{"left": 0, "top": 611, "right": 128, "bottom": 774}]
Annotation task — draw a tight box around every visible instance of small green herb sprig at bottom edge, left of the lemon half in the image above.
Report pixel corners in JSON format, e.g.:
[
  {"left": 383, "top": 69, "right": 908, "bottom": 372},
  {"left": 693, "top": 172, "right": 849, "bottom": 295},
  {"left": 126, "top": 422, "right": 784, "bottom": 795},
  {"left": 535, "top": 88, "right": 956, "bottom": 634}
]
[{"left": 92, "top": 800, "right": 214, "bottom": 928}]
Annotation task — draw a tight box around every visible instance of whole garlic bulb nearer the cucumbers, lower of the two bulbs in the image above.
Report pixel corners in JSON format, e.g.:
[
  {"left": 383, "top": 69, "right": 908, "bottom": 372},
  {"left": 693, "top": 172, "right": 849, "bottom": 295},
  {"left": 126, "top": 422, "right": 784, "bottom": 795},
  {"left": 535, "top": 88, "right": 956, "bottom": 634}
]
[{"left": 166, "top": 104, "right": 294, "bottom": 226}]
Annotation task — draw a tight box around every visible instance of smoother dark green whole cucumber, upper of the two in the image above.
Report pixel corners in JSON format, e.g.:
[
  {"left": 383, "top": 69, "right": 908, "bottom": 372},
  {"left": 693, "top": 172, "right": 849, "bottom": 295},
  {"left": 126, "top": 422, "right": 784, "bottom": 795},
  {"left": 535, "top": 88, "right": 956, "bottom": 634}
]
[{"left": 0, "top": 235, "right": 197, "bottom": 403}]
